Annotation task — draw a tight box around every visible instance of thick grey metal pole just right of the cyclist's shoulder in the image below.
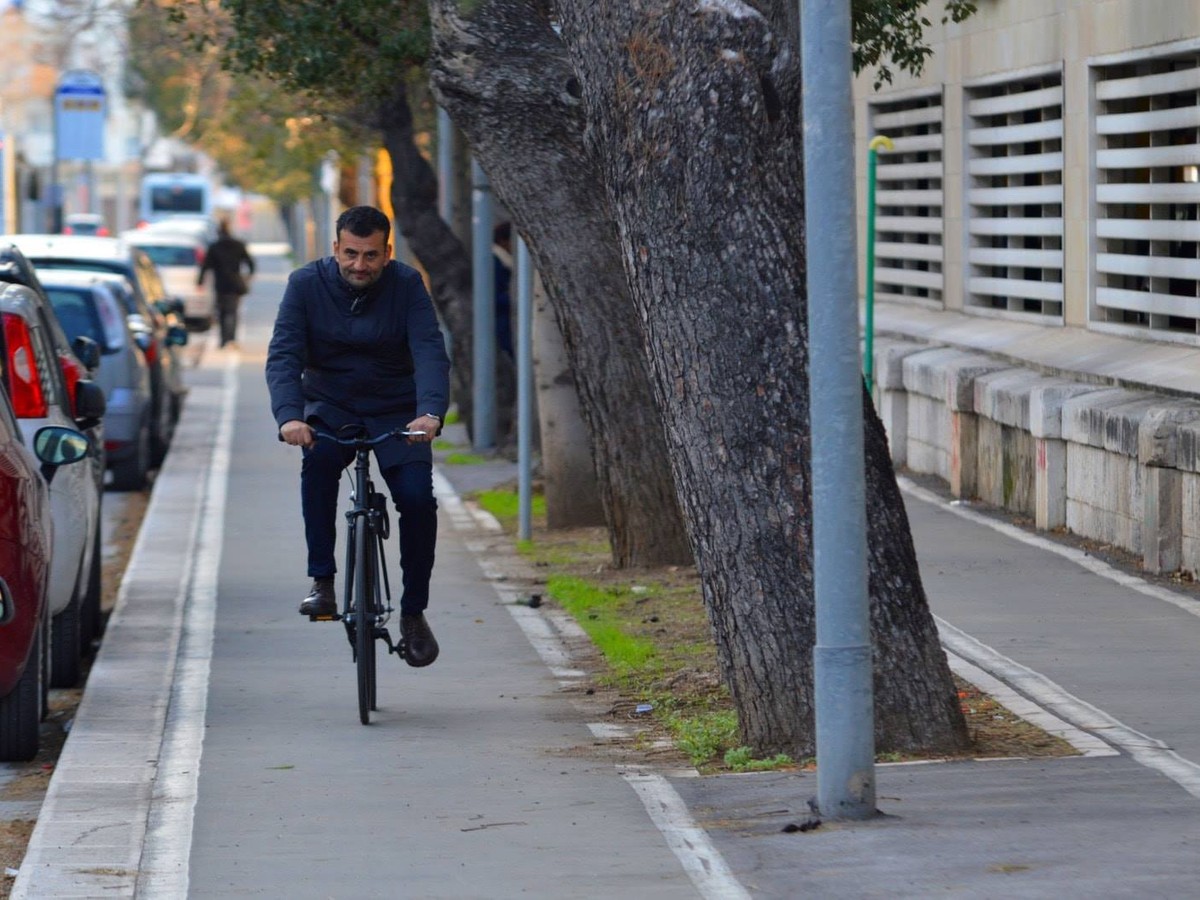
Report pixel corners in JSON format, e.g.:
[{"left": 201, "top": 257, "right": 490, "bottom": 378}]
[{"left": 470, "top": 160, "right": 496, "bottom": 450}]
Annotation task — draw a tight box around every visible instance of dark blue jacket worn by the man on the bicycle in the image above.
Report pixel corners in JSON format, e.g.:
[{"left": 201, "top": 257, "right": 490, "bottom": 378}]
[{"left": 266, "top": 257, "right": 450, "bottom": 458}]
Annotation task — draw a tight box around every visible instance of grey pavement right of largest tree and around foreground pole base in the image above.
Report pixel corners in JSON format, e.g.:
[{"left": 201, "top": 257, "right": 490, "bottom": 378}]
[{"left": 442, "top": 438, "right": 1200, "bottom": 900}]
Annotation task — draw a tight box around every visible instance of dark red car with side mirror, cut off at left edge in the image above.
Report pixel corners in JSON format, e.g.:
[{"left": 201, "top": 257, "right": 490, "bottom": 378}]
[{"left": 0, "top": 331, "right": 89, "bottom": 762}]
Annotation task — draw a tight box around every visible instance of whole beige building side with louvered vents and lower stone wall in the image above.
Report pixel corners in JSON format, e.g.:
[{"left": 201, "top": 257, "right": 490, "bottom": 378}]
[{"left": 854, "top": 0, "right": 1200, "bottom": 575}]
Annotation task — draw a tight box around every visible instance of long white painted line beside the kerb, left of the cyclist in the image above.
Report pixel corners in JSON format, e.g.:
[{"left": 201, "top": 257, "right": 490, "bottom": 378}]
[{"left": 137, "top": 352, "right": 239, "bottom": 900}]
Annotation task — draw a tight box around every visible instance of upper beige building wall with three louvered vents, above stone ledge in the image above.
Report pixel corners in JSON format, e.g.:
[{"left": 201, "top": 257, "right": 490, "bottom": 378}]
[{"left": 856, "top": 0, "right": 1200, "bottom": 344}]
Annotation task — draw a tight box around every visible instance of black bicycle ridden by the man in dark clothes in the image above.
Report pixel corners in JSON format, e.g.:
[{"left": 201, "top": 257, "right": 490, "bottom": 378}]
[{"left": 308, "top": 426, "right": 424, "bottom": 725}]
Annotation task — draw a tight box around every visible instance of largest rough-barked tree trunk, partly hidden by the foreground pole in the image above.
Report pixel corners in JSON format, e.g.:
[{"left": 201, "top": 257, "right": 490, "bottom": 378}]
[{"left": 558, "top": 0, "right": 966, "bottom": 757}]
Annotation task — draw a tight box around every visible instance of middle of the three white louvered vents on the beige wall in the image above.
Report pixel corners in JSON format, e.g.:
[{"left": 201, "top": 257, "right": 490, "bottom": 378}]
[{"left": 965, "top": 70, "right": 1063, "bottom": 322}]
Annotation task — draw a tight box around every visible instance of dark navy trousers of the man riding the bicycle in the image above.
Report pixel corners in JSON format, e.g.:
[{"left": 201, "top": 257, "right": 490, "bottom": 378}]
[{"left": 300, "top": 440, "right": 438, "bottom": 616}]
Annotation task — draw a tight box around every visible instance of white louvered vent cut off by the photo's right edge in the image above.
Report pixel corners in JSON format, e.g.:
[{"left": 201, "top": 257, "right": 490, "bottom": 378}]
[{"left": 1092, "top": 50, "right": 1200, "bottom": 340}]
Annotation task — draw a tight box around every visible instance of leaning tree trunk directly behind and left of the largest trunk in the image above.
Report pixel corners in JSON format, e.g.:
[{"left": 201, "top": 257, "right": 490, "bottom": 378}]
[{"left": 430, "top": 0, "right": 691, "bottom": 566}]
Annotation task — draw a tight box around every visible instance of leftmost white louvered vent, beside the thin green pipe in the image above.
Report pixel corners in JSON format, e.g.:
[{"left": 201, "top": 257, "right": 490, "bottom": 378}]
[{"left": 870, "top": 90, "right": 943, "bottom": 307}]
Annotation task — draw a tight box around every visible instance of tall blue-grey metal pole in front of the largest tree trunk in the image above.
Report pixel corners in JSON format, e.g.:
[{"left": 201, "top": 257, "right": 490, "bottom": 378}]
[{"left": 800, "top": 0, "right": 875, "bottom": 818}]
